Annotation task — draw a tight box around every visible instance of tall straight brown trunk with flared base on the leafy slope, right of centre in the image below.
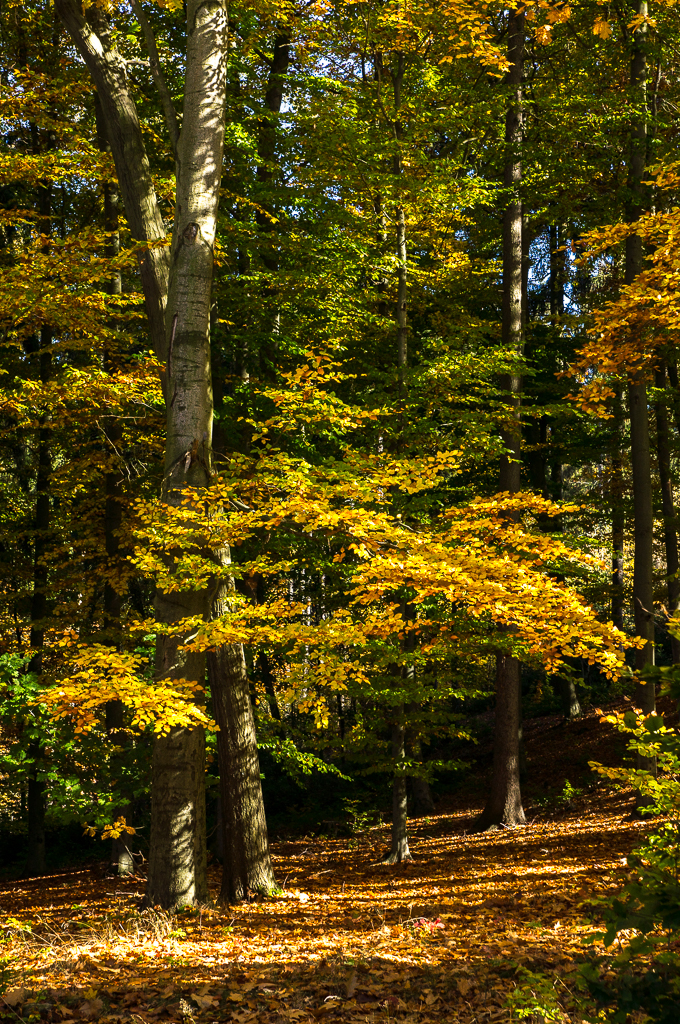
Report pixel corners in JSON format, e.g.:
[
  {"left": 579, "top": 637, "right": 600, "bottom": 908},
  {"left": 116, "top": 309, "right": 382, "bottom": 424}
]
[{"left": 475, "top": 10, "right": 525, "bottom": 830}]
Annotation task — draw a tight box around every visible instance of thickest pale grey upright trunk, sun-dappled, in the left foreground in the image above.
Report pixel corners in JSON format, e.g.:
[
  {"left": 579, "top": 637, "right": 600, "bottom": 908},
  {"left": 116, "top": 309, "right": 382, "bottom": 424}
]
[{"left": 146, "top": 0, "right": 227, "bottom": 906}]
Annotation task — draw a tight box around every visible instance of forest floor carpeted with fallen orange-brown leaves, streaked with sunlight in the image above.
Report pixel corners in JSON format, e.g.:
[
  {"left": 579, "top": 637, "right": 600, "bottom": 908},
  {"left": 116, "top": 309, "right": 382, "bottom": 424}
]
[{"left": 0, "top": 712, "right": 649, "bottom": 1024}]
